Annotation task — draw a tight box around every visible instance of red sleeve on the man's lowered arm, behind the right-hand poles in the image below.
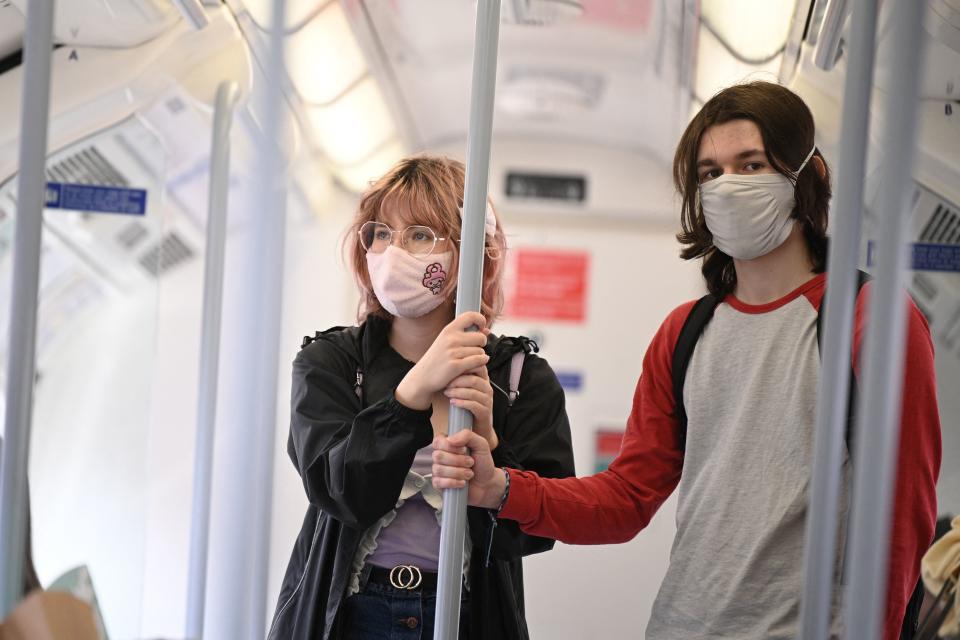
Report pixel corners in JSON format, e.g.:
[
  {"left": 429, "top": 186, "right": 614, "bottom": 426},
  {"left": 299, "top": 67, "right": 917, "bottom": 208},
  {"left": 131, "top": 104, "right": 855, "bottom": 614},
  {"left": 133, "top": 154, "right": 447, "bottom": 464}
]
[{"left": 853, "top": 284, "right": 941, "bottom": 640}]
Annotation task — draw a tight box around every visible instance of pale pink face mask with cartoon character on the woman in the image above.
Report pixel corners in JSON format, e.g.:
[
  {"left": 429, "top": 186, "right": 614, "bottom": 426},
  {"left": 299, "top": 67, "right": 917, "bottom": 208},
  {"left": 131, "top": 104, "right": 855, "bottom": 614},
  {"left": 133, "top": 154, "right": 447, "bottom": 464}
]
[{"left": 367, "top": 245, "right": 453, "bottom": 318}]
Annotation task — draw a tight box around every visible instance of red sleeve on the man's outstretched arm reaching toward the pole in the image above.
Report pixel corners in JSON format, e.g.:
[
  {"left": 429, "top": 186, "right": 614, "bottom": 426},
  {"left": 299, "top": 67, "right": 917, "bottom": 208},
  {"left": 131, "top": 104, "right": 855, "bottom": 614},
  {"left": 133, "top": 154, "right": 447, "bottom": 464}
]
[{"left": 501, "top": 302, "right": 694, "bottom": 544}]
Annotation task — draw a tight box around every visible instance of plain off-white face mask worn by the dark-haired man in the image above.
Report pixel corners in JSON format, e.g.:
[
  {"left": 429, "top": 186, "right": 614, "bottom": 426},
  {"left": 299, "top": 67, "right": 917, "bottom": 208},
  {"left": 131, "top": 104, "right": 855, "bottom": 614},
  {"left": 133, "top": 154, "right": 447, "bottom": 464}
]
[{"left": 700, "top": 147, "right": 816, "bottom": 260}]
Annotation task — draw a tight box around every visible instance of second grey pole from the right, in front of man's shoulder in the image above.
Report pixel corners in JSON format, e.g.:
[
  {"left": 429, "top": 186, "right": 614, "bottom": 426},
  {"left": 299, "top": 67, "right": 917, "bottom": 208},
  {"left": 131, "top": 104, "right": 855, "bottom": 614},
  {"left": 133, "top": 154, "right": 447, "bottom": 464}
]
[{"left": 800, "top": 0, "right": 877, "bottom": 640}]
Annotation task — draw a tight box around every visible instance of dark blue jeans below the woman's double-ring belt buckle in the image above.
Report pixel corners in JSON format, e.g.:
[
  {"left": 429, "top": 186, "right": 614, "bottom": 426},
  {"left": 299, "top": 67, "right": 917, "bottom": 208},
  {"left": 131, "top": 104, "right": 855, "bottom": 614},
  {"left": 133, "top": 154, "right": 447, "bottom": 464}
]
[{"left": 344, "top": 583, "right": 470, "bottom": 640}]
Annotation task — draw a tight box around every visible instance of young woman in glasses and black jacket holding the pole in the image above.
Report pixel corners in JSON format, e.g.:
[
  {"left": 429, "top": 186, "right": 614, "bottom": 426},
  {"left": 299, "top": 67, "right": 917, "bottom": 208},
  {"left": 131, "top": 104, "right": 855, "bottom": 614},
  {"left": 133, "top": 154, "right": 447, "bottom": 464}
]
[{"left": 269, "top": 156, "right": 574, "bottom": 640}]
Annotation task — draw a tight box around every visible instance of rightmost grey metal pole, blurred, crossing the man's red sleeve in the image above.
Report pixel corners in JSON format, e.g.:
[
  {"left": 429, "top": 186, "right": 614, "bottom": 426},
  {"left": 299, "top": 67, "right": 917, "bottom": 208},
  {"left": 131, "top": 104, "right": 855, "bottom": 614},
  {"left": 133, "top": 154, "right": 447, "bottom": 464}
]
[{"left": 844, "top": 0, "right": 926, "bottom": 640}]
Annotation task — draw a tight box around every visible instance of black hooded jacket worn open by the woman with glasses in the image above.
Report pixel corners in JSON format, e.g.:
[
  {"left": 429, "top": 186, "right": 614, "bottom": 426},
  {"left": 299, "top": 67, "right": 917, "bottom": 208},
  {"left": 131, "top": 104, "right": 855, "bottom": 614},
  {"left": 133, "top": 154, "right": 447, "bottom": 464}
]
[{"left": 268, "top": 316, "right": 574, "bottom": 640}]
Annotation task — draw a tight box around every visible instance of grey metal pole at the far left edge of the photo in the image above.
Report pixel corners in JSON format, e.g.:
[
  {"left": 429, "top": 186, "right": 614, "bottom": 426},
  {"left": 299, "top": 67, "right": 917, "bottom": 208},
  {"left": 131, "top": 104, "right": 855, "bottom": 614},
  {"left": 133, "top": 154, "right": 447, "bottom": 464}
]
[{"left": 0, "top": 0, "right": 54, "bottom": 618}]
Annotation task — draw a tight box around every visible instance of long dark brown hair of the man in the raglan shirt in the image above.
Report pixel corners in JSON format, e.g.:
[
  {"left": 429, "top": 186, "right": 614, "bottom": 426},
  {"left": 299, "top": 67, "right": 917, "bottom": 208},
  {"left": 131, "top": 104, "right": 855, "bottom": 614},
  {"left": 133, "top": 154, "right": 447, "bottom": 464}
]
[{"left": 673, "top": 82, "right": 831, "bottom": 297}]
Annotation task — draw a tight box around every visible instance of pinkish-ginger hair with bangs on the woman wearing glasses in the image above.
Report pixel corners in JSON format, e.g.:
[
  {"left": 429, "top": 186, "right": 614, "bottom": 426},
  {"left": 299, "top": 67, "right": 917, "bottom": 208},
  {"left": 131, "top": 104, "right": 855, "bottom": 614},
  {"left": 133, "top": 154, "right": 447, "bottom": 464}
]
[{"left": 344, "top": 154, "right": 507, "bottom": 326}]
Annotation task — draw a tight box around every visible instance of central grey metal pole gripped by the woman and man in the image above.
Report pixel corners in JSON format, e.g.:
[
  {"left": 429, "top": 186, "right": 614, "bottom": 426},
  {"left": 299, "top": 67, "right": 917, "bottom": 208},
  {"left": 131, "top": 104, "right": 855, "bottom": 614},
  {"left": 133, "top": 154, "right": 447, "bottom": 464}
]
[{"left": 433, "top": 0, "right": 500, "bottom": 640}]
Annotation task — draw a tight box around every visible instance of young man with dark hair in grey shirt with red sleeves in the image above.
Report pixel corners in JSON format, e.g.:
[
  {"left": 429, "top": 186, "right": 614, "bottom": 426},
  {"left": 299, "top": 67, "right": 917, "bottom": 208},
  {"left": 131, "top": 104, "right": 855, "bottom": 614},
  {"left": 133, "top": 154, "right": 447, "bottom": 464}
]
[{"left": 433, "top": 82, "right": 940, "bottom": 640}]
